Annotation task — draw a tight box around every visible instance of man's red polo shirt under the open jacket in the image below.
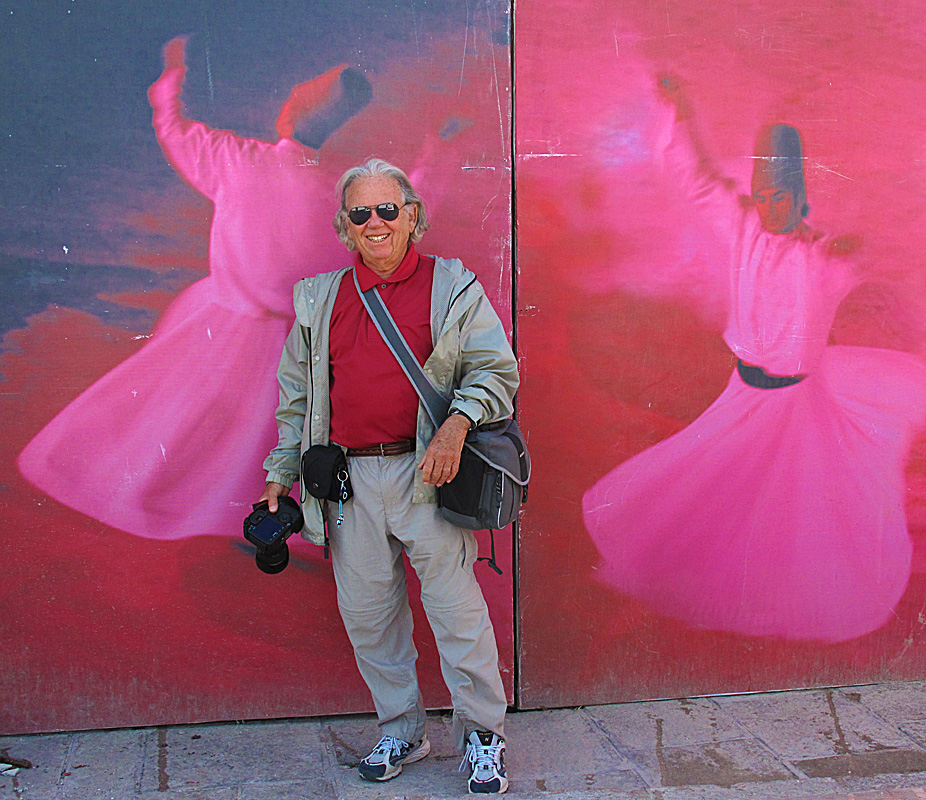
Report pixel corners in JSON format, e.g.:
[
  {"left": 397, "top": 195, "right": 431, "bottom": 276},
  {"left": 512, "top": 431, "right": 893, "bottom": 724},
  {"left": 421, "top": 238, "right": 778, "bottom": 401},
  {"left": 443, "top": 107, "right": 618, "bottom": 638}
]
[{"left": 328, "top": 246, "right": 434, "bottom": 447}]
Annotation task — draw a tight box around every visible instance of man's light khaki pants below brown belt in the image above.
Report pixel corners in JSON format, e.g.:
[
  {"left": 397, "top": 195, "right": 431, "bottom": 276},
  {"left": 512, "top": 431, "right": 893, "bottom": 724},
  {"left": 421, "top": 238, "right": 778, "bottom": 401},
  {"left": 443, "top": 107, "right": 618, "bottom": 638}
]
[{"left": 328, "top": 453, "right": 507, "bottom": 751}]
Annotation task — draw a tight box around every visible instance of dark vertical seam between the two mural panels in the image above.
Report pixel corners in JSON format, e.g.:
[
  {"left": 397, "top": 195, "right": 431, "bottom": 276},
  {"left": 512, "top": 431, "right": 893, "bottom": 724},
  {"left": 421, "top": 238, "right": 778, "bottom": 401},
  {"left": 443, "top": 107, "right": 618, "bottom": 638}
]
[{"left": 508, "top": 0, "right": 521, "bottom": 709}]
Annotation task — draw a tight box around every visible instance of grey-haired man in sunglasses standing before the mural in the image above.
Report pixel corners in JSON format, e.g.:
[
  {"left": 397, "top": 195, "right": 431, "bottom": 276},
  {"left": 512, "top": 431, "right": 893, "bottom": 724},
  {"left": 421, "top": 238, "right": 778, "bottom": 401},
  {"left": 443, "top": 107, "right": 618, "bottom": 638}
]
[{"left": 264, "top": 159, "right": 518, "bottom": 793}]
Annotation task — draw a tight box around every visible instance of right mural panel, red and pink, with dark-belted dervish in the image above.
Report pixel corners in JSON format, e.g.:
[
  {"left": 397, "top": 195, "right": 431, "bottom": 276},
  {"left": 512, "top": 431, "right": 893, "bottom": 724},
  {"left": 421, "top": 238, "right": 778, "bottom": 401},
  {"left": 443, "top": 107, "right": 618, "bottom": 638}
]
[{"left": 515, "top": 0, "right": 926, "bottom": 706}]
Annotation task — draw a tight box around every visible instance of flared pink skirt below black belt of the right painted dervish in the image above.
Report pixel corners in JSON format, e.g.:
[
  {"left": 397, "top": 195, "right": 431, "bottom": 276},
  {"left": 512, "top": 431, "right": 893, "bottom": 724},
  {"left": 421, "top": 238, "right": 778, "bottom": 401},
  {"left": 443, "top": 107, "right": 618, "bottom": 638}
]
[{"left": 583, "top": 347, "right": 926, "bottom": 642}]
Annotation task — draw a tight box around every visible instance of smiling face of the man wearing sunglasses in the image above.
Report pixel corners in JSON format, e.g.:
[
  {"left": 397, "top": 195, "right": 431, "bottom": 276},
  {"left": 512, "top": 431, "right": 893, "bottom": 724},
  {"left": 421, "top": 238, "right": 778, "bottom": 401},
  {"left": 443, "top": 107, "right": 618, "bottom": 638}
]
[{"left": 347, "top": 175, "right": 418, "bottom": 276}]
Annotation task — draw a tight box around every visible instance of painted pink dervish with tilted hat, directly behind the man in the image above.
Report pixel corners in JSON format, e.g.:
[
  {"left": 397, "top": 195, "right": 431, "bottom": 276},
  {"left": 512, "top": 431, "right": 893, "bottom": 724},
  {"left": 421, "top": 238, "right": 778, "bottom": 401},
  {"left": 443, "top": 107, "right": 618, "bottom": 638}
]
[{"left": 18, "top": 37, "right": 372, "bottom": 539}]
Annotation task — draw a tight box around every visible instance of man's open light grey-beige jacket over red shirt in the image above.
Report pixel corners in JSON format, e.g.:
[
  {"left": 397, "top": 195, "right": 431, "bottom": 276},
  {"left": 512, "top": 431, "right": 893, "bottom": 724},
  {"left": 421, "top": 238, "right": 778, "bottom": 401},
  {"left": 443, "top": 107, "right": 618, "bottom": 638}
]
[{"left": 264, "top": 258, "right": 518, "bottom": 544}]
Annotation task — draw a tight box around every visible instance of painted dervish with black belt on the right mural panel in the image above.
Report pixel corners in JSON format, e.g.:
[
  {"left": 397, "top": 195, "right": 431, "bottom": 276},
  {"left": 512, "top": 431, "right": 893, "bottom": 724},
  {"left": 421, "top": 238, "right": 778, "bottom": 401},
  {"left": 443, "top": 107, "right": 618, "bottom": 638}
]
[{"left": 583, "top": 76, "right": 926, "bottom": 642}]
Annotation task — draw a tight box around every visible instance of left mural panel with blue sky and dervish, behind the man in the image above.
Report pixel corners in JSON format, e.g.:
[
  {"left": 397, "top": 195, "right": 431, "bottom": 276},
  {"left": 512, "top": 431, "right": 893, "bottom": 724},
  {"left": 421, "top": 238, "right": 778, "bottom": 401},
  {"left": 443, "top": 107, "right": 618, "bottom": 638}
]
[{"left": 0, "top": 0, "right": 514, "bottom": 732}]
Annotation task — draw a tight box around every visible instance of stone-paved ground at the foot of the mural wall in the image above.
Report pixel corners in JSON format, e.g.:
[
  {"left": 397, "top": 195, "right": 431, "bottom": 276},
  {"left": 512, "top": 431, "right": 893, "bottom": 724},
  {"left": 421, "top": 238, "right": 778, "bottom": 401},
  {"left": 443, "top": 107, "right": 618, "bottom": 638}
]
[{"left": 0, "top": 682, "right": 926, "bottom": 800}]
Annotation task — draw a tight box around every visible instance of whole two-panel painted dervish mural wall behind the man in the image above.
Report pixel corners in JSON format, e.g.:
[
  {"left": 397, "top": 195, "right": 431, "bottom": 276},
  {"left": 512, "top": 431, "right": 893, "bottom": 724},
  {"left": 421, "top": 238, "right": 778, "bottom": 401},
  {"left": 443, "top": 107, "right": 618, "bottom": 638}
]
[{"left": 0, "top": 0, "right": 926, "bottom": 733}]
